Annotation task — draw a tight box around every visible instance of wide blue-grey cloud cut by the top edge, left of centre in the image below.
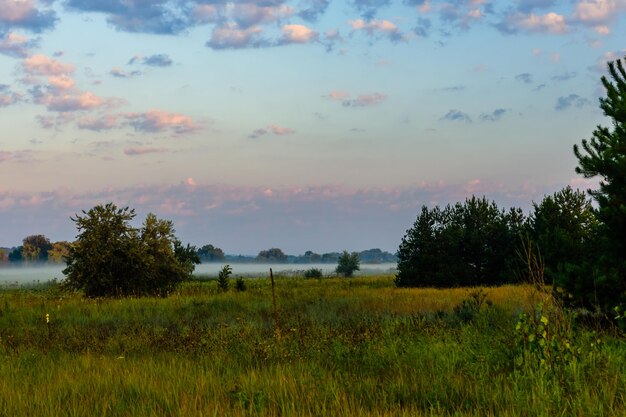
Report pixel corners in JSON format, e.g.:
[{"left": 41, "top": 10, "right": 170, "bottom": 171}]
[{"left": 65, "top": 0, "right": 193, "bottom": 34}]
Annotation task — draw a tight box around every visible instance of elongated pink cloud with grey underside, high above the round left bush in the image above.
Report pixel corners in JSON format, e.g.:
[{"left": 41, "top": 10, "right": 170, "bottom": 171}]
[{"left": 124, "top": 110, "right": 200, "bottom": 134}]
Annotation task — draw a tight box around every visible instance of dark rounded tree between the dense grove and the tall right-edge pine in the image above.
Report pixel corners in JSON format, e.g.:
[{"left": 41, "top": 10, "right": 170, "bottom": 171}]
[{"left": 528, "top": 186, "right": 600, "bottom": 283}]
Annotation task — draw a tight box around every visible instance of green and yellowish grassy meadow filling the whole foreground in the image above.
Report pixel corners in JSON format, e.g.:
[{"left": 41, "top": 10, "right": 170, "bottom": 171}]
[{"left": 0, "top": 276, "right": 626, "bottom": 417}]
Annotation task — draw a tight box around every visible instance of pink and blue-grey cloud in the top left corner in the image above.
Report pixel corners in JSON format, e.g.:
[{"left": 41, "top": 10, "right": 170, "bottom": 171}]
[{"left": 0, "top": 0, "right": 58, "bottom": 33}]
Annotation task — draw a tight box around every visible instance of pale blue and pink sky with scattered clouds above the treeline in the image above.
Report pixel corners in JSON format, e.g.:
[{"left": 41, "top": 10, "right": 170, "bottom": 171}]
[{"left": 0, "top": 0, "right": 626, "bottom": 254}]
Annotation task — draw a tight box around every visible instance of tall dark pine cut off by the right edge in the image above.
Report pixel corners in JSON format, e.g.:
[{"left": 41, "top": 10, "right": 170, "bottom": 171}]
[{"left": 558, "top": 55, "right": 626, "bottom": 311}]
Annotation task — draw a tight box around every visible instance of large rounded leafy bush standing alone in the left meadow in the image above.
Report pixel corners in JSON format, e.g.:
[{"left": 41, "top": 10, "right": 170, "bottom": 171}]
[{"left": 63, "top": 203, "right": 195, "bottom": 297}]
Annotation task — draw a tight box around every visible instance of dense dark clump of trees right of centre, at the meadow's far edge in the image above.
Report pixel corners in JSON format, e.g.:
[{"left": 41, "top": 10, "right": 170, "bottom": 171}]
[{"left": 396, "top": 196, "right": 524, "bottom": 287}]
